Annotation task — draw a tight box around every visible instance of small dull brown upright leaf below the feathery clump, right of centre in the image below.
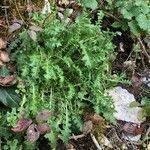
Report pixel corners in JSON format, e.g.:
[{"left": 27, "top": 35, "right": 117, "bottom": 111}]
[{"left": 82, "top": 120, "right": 93, "bottom": 135}]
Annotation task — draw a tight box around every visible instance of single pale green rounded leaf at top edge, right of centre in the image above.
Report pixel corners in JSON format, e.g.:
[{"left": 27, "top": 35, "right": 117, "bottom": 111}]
[{"left": 82, "top": 0, "right": 98, "bottom": 10}]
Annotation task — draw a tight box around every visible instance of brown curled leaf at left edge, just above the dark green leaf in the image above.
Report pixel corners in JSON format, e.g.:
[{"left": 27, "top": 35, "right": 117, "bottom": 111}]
[{"left": 0, "top": 75, "right": 17, "bottom": 86}]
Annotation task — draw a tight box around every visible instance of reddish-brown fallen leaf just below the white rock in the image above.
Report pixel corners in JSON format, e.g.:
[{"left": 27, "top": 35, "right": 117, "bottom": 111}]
[{"left": 123, "top": 123, "right": 143, "bottom": 136}]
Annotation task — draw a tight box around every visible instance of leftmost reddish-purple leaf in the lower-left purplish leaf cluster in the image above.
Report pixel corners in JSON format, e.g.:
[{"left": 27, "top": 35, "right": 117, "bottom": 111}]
[{"left": 11, "top": 118, "right": 32, "bottom": 132}]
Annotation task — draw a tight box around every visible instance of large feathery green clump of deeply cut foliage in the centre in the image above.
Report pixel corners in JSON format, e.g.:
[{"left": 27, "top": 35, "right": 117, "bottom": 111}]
[{"left": 4, "top": 14, "right": 123, "bottom": 147}]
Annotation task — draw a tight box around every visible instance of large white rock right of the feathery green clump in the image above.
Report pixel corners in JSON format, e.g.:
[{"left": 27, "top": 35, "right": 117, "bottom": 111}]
[{"left": 108, "top": 87, "right": 143, "bottom": 124}]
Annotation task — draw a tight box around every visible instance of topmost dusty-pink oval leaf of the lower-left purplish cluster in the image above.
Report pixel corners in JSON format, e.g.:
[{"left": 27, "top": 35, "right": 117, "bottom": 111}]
[{"left": 36, "top": 110, "right": 52, "bottom": 122}]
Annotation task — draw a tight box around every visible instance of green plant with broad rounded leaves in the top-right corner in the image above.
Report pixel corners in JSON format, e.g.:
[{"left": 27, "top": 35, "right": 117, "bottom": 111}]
[{"left": 108, "top": 0, "right": 150, "bottom": 37}]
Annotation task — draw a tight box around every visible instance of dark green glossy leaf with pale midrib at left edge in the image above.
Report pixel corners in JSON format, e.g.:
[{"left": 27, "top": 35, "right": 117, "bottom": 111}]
[{"left": 0, "top": 87, "right": 20, "bottom": 107}]
